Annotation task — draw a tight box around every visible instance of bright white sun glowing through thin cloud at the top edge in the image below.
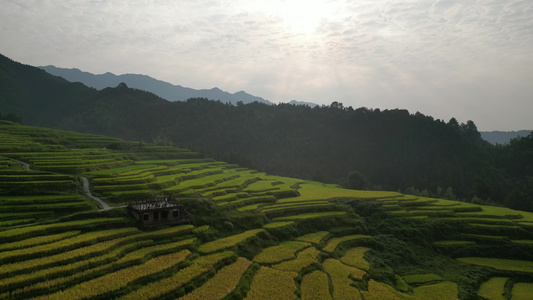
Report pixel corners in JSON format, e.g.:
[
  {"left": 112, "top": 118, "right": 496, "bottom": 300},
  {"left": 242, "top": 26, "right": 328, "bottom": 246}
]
[{"left": 278, "top": 0, "right": 331, "bottom": 36}]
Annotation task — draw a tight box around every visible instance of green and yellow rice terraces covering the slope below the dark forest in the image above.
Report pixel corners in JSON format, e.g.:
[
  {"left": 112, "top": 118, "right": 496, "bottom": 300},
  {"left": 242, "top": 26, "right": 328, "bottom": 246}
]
[{"left": 0, "top": 122, "right": 533, "bottom": 300}]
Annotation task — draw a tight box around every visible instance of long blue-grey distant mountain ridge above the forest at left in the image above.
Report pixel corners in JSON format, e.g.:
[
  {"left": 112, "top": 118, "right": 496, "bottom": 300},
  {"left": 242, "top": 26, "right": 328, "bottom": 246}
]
[{"left": 39, "top": 65, "right": 274, "bottom": 104}]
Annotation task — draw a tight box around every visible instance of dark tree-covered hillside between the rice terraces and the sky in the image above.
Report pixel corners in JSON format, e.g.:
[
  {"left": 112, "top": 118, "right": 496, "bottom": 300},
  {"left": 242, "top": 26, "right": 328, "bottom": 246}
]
[{"left": 0, "top": 57, "right": 533, "bottom": 210}]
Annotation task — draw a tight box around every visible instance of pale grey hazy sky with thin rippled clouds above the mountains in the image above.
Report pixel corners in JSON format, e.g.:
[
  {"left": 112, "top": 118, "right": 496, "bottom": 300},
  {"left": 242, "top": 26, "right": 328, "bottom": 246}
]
[{"left": 0, "top": 0, "right": 533, "bottom": 130}]
